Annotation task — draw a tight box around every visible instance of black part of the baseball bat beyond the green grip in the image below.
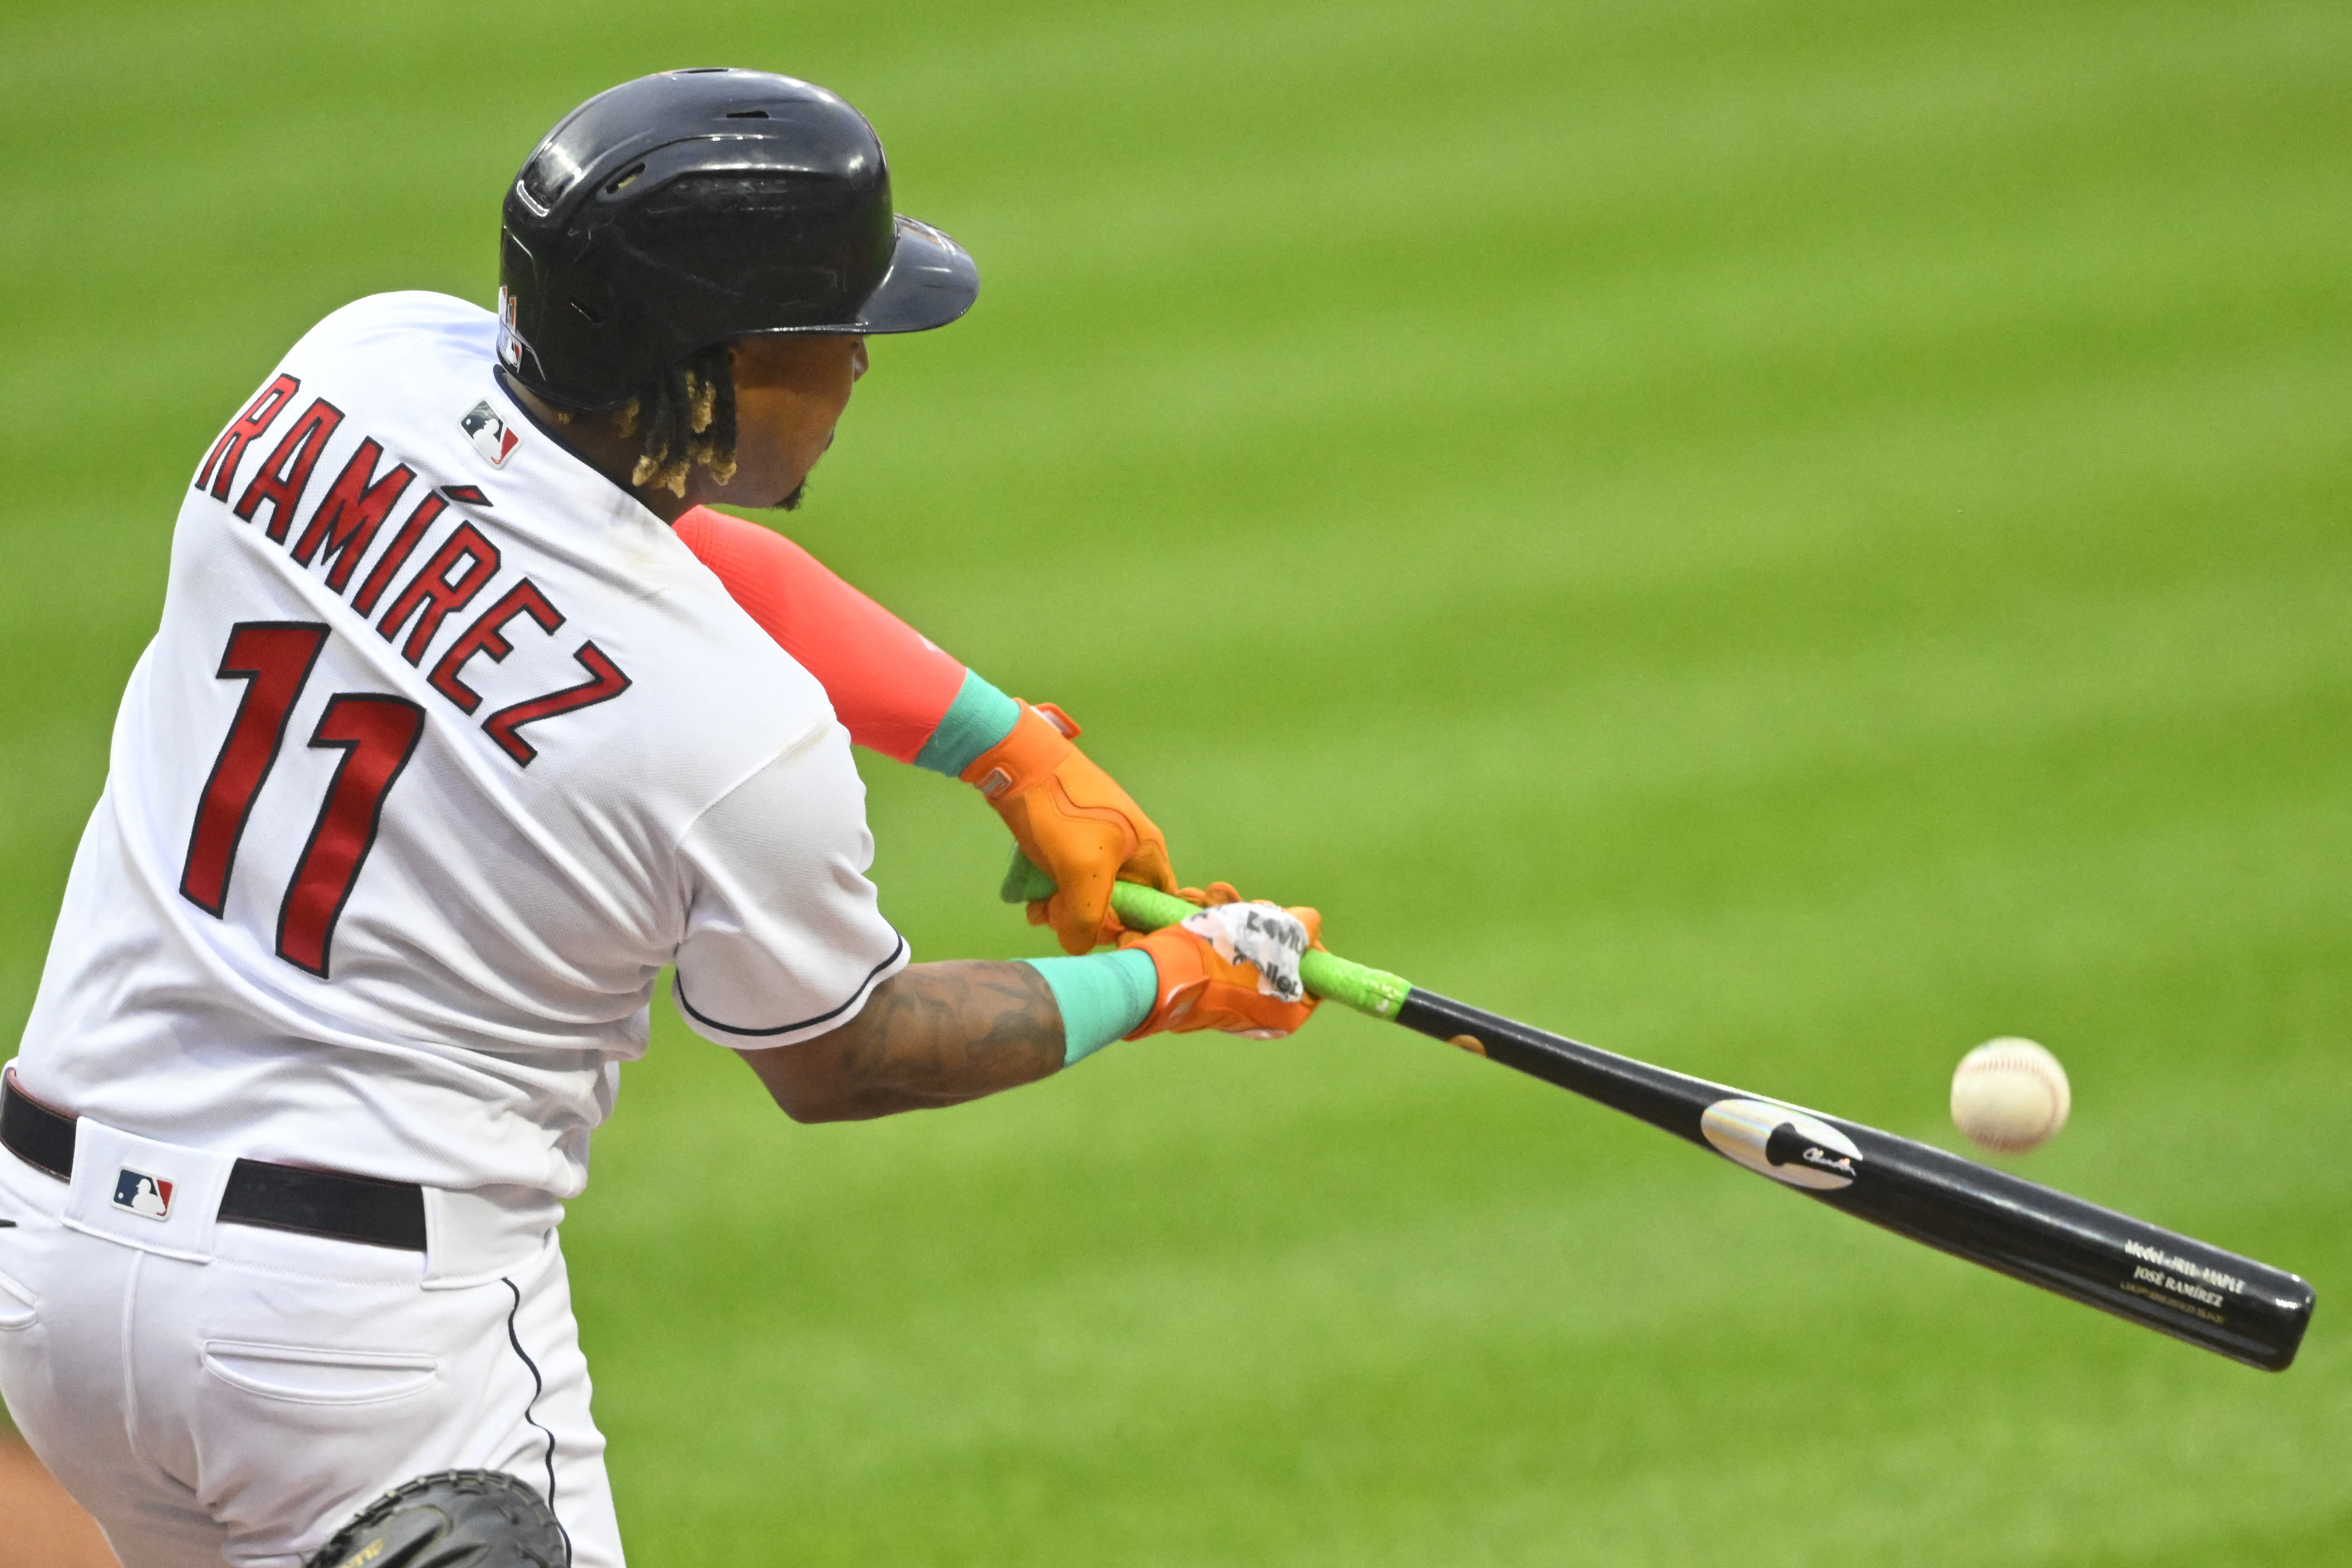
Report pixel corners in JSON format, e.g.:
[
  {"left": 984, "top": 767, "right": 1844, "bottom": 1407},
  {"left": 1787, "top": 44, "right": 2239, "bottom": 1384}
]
[{"left": 1397, "top": 987, "right": 2312, "bottom": 1371}]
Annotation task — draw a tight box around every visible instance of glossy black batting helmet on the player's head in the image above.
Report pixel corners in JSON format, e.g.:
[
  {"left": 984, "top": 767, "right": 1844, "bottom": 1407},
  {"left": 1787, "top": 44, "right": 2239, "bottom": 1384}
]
[{"left": 499, "top": 68, "right": 981, "bottom": 409}]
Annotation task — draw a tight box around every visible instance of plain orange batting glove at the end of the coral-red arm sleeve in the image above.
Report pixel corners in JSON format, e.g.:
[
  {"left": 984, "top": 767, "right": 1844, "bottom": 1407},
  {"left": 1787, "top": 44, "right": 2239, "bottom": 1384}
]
[{"left": 962, "top": 703, "right": 1176, "bottom": 954}]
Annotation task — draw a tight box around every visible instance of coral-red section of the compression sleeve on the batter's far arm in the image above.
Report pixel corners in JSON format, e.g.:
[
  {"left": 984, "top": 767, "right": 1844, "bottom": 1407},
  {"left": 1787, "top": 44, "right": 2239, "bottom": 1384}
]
[{"left": 673, "top": 505, "right": 964, "bottom": 762}]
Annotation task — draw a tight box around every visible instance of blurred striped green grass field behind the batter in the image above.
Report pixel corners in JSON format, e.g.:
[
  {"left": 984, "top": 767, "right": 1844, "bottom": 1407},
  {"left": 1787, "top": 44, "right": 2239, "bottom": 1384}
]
[{"left": 0, "top": 0, "right": 2352, "bottom": 1568}]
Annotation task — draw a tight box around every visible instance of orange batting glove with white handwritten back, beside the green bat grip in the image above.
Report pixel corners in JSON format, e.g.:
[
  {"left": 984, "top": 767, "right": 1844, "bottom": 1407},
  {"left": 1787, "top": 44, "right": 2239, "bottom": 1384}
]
[{"left": 1120, "top": 881, "right": 1322, "bottom": 1039}]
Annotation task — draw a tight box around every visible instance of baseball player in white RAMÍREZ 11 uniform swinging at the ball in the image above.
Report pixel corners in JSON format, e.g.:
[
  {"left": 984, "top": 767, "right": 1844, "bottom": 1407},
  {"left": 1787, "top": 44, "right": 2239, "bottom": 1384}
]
[{"left": 0, "top": 71, "right": 1315, "bottom": 1568}]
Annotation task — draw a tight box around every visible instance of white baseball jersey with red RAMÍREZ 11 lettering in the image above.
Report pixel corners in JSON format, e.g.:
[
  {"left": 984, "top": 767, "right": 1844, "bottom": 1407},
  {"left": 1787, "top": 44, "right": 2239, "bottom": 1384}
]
[{"left": 16, "top": 294, "right": 908, "bottom": 1196}]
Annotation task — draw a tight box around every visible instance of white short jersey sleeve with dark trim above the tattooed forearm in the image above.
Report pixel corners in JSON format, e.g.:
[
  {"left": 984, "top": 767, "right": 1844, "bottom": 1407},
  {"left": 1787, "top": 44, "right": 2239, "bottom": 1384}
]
[{"left": 673, "top": 724, "right": 908, "bottom": 1051}]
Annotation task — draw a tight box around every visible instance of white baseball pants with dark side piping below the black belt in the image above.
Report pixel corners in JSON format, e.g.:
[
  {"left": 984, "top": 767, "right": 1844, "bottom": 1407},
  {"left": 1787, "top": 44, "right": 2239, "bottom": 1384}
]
[{"left": 0, "top": 1121, "right": 621, "bottom": 1568}]
